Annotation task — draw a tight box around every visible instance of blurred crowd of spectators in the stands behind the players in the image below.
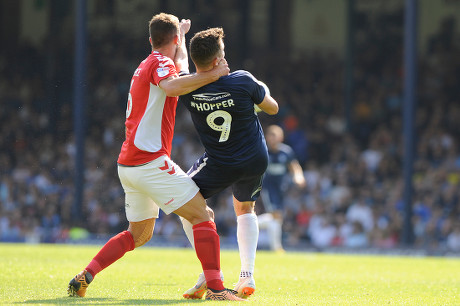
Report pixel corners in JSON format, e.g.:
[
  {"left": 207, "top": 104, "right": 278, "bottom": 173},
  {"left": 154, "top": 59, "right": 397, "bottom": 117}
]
[{"left": 0, "top": 10, "right": 460, "bottom": 252}]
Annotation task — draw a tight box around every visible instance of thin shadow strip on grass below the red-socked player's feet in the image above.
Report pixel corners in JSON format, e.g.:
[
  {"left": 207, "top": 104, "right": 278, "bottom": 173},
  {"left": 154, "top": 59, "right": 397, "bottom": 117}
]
[{"left": 14, "top": 297, "right": 204, "bottom": 305}]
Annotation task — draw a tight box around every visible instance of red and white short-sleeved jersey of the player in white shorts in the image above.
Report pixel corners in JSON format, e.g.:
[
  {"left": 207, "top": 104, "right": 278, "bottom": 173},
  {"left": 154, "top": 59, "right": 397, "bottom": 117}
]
[{"left": 118, "top": 51, "right": 178, "bottom": 166}]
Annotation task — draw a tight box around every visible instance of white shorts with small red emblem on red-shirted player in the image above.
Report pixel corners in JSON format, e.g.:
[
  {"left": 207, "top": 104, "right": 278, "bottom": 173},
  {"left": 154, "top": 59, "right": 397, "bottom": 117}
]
[{"left": 118, "top": 156, "right": 199, "bottom": 222}]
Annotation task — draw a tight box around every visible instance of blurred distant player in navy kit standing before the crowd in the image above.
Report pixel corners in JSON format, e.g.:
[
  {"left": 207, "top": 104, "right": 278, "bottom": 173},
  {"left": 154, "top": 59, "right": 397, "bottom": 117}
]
[{"left": 259, "top": 125, "right": 306, "bottom": 251}]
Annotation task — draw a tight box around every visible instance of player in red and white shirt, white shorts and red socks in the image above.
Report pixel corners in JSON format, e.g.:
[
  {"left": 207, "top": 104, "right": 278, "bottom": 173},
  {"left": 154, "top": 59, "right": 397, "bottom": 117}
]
[{"left": 68, "top": 13, "right": 241, "bottom": 300}]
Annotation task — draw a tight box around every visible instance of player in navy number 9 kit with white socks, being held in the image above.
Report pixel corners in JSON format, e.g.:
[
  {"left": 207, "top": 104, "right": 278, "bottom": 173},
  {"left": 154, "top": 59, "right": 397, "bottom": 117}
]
[{"left": 179, "top": 28, "right": 278, "bottom": 298}]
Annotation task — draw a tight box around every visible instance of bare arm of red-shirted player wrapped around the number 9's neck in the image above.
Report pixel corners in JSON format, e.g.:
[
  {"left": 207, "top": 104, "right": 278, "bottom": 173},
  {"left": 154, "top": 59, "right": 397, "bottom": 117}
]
[{"left": 158, "top": 59, "right": 230, "bottom": 97}]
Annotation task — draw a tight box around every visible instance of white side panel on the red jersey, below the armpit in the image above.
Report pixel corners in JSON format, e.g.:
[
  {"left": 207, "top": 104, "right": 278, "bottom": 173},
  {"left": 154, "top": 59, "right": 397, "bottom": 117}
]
[{"left": 134, "top": 83, "right": 166, "bottom": 152}]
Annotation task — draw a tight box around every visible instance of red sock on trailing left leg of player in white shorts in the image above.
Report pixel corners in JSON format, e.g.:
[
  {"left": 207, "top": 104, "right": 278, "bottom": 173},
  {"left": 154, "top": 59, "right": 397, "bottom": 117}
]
[{"left": 86, "top": 231, "right": 134, "bottom": 277}]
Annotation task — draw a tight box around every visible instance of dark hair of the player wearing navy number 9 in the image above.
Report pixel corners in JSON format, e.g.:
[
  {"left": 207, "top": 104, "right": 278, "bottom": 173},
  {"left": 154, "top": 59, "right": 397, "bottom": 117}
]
[{"left": 190, "top": 28, "right": 225, "bottom": 67}]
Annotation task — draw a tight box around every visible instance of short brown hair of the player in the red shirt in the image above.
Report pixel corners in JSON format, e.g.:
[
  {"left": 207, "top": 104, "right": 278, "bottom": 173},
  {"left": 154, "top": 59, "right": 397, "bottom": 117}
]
[{"left": 149, "top": 13, "right": 179, "bottom": 48}]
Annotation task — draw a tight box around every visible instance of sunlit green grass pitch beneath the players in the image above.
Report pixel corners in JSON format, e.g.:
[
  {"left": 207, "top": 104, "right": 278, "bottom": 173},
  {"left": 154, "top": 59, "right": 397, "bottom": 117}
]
[{"left": 0, "top": 244, "right": 460, "bottom": 305}]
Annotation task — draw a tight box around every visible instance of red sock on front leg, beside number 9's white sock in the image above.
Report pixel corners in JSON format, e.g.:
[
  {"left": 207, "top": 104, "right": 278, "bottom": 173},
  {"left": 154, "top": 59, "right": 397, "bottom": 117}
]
[{"left": 193, "top": 221, "right": 224, "bottom": 290}]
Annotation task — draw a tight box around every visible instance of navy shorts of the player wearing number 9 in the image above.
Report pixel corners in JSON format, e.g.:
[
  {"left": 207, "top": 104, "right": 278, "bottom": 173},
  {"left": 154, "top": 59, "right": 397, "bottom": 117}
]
[{"left": 187, "top": 153, "right": 268, "bottom": 202}]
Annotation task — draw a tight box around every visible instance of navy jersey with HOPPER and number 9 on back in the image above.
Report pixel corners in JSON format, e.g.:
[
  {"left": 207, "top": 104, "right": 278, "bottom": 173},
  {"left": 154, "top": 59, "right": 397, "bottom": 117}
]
[{"left": 179, "top": 70, "right": 267, "bottom": 165}]
